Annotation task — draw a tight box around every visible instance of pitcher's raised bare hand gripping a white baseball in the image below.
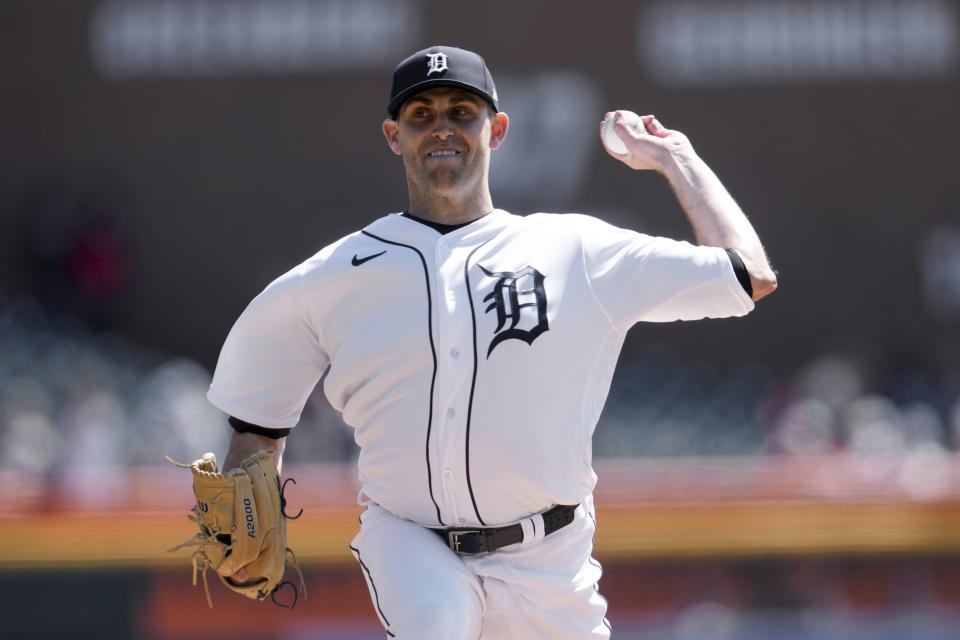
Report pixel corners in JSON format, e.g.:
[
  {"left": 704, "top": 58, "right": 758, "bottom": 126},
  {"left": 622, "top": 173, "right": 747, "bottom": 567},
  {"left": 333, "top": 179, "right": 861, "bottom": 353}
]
[{"left": 600, "top": 110, "right": 690, "bottom": 171}]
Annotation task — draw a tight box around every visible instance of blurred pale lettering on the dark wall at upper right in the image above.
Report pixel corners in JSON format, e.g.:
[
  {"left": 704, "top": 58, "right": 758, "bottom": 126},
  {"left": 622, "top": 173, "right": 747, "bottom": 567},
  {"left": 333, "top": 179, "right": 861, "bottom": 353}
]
[{"left": 636, "top": 0, "right": 957, "bottom": 87}]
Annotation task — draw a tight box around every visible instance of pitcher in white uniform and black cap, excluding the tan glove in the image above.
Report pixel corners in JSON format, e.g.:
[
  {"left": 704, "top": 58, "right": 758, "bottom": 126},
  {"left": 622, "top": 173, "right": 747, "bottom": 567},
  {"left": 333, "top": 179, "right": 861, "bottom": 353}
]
[{"left": 186, "top": 46, "right": 777, "bottom": 640}]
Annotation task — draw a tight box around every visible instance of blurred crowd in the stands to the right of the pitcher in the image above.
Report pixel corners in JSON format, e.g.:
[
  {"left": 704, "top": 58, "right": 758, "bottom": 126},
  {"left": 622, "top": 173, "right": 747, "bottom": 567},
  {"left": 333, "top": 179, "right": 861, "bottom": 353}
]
[{"left": 594, "top": 345, "right": 960, "bottom": 457}]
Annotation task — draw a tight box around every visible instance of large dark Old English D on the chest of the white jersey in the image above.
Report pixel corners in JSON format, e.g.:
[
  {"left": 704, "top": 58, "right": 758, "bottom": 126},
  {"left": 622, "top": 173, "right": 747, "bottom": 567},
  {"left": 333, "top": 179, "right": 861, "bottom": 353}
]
[{"left": 478, "top": 265, "right": 550, "bottom": 358}]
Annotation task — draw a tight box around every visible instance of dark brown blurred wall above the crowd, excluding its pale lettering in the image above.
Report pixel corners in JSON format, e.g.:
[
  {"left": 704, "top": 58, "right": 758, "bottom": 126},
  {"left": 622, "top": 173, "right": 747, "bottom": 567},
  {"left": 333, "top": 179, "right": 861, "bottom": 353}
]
[{"left": 0, "top": 0, "right": 960, "bottom": 378}]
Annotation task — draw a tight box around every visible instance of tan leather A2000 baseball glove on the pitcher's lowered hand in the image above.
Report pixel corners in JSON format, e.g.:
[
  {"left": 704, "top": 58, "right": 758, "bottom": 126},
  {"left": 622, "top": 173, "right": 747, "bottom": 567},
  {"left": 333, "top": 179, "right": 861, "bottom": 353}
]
[{"left": 167, "top": 450, "right": 306, "bottom": 609}]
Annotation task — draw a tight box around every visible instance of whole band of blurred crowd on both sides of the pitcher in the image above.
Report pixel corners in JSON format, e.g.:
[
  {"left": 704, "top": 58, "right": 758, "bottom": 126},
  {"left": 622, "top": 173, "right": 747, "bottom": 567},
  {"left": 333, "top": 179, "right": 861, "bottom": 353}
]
[{"left": 0, "top": 297, "right": 960, "bottom": 475}]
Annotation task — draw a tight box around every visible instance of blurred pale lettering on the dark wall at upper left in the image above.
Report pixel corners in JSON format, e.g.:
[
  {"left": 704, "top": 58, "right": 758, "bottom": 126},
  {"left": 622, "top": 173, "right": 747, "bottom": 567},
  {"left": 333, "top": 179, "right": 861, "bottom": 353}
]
[{"left": 89, "top": 0, "right": 421, "bottom": 78}]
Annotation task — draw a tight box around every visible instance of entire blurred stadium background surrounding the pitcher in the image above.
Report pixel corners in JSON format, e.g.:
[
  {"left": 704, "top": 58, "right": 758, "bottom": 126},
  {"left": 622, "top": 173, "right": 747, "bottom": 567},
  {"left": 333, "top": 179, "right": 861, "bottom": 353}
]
[{"left": 0, "top": 0, "right": 960, "bottom": 640}]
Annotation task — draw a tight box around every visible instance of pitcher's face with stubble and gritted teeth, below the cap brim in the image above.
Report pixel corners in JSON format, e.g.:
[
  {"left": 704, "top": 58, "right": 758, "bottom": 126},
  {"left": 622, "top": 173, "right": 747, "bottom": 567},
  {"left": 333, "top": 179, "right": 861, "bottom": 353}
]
[{"left": 383, "top": 87, "right": 506, "bottom": 191}]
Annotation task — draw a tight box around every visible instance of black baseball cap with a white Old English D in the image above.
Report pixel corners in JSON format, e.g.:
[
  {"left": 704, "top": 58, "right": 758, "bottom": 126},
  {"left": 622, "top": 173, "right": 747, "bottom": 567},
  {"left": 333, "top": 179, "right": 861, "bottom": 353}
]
[{"left": 387, "top": 45, "right": 500, "bottom": 119}]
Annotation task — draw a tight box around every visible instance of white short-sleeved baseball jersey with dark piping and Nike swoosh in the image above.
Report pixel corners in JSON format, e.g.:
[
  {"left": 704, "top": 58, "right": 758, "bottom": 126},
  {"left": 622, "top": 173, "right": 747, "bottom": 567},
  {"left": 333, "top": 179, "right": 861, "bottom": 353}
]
[{"left": 208, "top": 210, "right": 753, "bottom": 527}]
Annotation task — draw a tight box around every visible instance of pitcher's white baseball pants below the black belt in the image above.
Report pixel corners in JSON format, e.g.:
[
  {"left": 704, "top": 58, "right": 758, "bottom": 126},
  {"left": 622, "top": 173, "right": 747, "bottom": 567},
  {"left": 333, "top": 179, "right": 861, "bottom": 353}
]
[{"left": 350, "top": 497, "right": 610, "bottom": 640}]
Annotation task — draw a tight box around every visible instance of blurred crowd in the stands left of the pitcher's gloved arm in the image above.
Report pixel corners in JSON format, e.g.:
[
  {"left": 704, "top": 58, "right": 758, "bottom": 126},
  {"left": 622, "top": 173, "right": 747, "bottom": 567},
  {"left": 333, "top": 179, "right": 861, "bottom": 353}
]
[{"left": 0, "top": 300, "right": 226, "bottom": 475}]
